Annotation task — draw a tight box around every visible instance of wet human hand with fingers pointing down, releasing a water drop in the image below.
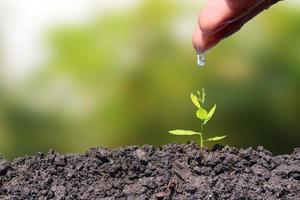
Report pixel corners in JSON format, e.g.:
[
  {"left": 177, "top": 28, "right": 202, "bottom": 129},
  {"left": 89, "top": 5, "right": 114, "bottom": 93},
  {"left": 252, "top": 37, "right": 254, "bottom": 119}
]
[{"left": 193, "top": 0, "right": 280, "bottom": 52}]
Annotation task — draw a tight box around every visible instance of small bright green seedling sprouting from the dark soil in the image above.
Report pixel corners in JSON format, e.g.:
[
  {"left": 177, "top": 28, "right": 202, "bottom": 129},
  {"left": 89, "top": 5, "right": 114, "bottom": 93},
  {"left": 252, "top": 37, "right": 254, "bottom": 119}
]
[{"left": 169, "top": 89, "right": 226, "bottom": 148}]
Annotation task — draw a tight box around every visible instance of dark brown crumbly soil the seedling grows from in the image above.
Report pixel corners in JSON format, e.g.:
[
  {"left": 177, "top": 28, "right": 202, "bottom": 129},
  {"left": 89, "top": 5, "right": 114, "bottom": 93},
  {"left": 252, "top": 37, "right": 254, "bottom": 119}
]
[{"left": 0, "top": 143, "right": 300, "bottom": 200}]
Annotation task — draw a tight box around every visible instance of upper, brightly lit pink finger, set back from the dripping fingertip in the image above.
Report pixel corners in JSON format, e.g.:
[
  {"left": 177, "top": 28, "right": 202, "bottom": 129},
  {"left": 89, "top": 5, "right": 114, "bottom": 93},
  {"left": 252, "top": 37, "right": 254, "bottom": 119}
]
[{"left": 198, "top": 0, "right": 269, "bottom": 34}]
